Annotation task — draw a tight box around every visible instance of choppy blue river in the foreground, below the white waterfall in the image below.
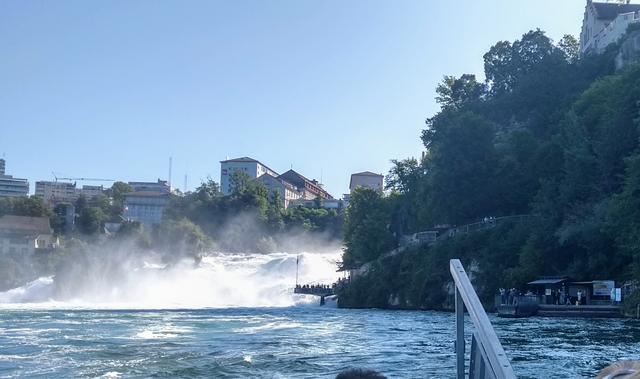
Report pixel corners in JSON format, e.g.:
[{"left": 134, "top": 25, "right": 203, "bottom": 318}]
[{"left": 0, "top": 306, "right": 640, "bottom": 378}]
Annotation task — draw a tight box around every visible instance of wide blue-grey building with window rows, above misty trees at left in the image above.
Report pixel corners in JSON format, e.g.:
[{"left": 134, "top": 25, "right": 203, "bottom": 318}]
[{"left": 122, "top": 191, "right": 169, "bottom": 226}]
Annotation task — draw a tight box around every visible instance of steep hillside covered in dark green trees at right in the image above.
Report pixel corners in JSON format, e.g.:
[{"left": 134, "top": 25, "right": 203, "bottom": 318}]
[{"left": 341, "top": 30, "right": 640, "bottom": 308}]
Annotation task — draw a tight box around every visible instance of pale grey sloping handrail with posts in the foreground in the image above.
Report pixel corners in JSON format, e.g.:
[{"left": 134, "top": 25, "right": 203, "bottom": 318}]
[{"left": 449, "top": 259, "right": 516, "bottom": 379}]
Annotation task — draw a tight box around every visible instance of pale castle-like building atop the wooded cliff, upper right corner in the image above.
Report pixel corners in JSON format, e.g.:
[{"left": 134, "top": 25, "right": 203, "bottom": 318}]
[{"left": 580, "top": 0, "right": 640, "bottom": 55}]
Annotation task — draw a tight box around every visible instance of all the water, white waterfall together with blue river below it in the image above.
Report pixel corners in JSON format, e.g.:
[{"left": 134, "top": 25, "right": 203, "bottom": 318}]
[{"left": 0, "top": 254, "right": 640, "bottom": 378}]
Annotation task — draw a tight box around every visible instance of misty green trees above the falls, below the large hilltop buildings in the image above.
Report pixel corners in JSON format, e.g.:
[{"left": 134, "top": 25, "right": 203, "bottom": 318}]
[{"left": 165, "top": 177, "right": 342, "bottom": 251}]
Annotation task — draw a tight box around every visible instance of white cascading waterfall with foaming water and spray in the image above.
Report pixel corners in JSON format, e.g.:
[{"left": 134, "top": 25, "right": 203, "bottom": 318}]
[{"left": 0, "top": 250, "right": 340, "bottom": 309}]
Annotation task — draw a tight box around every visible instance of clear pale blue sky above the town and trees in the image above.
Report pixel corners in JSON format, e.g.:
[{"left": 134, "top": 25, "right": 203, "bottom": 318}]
[{"left": 0, "top": 0, "right": 586, "bottom": 197}]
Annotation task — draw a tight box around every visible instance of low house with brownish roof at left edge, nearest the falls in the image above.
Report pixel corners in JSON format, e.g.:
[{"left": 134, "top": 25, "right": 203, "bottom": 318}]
[{"left": 0, "top": 215, "right": 58, "bottom": 256}]
